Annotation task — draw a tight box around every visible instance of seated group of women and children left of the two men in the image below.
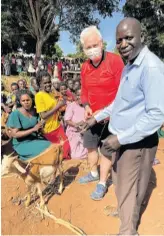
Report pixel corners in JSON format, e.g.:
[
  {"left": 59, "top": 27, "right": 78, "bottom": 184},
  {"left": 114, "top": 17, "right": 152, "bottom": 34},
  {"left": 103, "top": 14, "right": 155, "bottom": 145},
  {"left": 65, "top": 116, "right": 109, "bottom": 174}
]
[{"left": 1, "top": 70, "right": 87, "bottom": 160}]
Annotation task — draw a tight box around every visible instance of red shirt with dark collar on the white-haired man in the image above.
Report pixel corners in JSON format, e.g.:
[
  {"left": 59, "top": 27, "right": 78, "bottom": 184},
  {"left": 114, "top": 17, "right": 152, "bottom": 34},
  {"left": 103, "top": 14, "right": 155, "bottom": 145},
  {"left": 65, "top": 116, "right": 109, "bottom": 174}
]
[{"left": 81, "top": 52, "right": 124, "bottom": 112}]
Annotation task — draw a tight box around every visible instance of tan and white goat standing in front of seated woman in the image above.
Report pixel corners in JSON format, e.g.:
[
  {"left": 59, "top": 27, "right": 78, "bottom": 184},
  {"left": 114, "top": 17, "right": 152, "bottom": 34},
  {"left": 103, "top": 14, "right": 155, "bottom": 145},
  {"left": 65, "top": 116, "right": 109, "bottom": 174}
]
[{"left": 1, "top": 143, "right": 64, "bottom": 208}]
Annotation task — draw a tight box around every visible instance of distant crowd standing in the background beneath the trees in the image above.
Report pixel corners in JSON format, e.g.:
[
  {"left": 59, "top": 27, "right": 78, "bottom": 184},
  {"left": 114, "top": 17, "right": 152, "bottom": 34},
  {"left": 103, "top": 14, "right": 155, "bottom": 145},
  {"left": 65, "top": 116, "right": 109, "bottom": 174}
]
[{"left": 1, "top": 54, "right": 83, "bottom": 79}]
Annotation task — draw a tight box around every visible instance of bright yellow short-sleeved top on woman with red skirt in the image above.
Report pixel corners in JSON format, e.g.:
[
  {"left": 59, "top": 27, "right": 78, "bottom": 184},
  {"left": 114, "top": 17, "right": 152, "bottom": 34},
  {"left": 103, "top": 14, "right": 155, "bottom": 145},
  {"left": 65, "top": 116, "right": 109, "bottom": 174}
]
[{"left": 35, "top": 91, "right": 60, "bottom": 133}]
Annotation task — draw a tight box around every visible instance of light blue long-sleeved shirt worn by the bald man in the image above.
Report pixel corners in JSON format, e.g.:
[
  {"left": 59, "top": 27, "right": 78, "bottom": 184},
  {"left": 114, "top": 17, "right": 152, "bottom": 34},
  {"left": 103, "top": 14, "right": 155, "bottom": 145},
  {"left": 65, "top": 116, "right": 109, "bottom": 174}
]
[{"left": 95, "top": 46, "right": 164, "bottom": 145}]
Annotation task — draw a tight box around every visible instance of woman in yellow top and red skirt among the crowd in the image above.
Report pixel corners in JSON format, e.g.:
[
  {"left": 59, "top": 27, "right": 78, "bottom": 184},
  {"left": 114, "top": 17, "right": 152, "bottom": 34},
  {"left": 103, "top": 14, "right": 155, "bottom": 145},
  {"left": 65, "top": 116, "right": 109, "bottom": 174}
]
[{"left": 35, "top": 71, "right": 70, "bottom": 159}]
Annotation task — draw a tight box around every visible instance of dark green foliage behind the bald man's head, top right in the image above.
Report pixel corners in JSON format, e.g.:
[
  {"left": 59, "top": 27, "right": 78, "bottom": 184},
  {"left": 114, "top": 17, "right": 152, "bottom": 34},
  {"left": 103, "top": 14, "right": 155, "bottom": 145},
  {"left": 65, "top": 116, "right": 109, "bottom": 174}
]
[{"left": 123, "top": 0, "right": 164, "bottom": 59}]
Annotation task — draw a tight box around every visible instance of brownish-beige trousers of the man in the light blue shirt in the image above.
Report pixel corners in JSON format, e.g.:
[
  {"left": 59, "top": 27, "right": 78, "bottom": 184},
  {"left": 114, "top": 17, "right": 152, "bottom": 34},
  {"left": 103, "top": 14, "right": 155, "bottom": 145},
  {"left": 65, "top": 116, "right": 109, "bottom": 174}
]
[{"left": 112, "top": 134, "right": 158, "bottom": 235}]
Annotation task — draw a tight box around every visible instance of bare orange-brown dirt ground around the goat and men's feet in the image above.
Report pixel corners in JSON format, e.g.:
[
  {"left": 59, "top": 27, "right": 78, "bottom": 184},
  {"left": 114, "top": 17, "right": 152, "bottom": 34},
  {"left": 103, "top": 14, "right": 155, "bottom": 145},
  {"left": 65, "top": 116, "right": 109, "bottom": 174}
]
[{"left": 1, "top": 139, "right": 164, "bottom": 235}]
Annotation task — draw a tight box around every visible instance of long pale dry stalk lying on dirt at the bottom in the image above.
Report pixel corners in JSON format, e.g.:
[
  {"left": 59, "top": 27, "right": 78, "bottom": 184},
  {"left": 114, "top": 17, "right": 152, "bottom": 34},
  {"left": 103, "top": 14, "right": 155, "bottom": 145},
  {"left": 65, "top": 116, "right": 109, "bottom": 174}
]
[{"left": 36, "top": 207, "right": 86, "bottom": 235}]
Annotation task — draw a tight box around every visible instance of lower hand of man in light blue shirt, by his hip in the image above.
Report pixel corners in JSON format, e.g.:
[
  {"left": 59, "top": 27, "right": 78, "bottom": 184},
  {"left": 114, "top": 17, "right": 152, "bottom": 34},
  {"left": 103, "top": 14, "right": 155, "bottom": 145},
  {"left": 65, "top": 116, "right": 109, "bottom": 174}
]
[{"left": 103, "top": 135, "right": 121, "bottom": 151}]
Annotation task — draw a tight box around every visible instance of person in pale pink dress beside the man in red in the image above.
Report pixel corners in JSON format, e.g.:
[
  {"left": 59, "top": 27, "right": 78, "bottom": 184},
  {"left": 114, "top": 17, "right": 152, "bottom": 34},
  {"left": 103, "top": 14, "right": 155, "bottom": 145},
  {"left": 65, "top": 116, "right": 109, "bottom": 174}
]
[{"left": 64, "top": 89, "right": 87, "bottom": 159}]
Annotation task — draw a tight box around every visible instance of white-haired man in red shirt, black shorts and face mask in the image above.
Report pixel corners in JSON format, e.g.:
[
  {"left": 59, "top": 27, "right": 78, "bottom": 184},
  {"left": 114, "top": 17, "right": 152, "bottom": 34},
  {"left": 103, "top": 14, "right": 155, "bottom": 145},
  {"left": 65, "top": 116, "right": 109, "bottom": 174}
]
[{"left": 79, "top": 26, "right": 124, "bottom": 200}]
